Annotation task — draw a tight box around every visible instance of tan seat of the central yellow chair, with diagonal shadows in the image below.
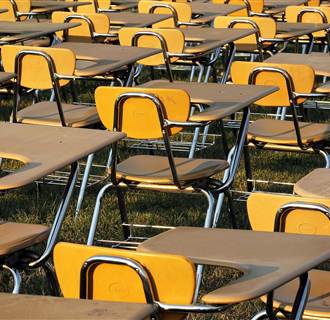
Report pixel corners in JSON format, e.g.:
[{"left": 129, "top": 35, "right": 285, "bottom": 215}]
[{"left": 117, "top": 155, "right": 229, "bottom": 184}]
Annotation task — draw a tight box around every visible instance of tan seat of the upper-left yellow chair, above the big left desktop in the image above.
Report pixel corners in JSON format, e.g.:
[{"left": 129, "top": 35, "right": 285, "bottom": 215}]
[{"left": 17, "top": 101, "right": 100, "bottom": 128}]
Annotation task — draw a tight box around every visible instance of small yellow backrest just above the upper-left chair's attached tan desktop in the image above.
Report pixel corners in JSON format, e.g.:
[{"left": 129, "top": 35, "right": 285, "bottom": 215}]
[{"left": 52, "top": 11, "right": 110, "bottom": 42}]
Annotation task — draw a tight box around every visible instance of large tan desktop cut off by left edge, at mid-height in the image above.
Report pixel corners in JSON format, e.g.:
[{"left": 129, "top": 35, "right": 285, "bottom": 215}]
[{"left": 0, "top": 122, "right": 125, "bottom": 190}]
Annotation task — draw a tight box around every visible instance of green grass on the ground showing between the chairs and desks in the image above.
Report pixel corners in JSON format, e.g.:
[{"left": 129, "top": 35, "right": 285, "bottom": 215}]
[{"left": 0, "top": 69, "right": 328, "bottom": 319}]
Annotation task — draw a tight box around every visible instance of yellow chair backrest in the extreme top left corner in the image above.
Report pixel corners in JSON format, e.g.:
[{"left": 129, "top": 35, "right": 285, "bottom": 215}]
[{"left": 0, "top": 0, "right": 31, "bottom": 21}]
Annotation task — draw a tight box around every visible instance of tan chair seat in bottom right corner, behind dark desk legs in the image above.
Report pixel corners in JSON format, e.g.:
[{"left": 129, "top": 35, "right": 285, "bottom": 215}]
[{"left": 262, "top": 270, "right": 330, "bottom": 319}]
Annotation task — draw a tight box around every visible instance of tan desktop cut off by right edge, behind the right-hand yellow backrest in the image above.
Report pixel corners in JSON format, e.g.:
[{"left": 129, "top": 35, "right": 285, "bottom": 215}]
[{"left": 265, "top": 52, "right": 330, "bottom": 77}]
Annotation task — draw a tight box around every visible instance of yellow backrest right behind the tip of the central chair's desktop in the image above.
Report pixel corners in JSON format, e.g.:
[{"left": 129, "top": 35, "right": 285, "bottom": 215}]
[{"left": 231, "top": 61, "right": 315, "bottom": 107}]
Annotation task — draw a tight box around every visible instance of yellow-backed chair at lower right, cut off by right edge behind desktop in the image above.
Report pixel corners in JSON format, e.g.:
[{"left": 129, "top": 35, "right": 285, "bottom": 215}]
[{"left": 247, "top": 192, "right": 330, "bottom": 320}]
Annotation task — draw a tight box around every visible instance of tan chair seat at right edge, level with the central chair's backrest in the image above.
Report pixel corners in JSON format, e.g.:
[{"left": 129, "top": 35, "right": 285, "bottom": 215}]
[{"left": 248, "top": 119, "right": 330, "bottom": 146}]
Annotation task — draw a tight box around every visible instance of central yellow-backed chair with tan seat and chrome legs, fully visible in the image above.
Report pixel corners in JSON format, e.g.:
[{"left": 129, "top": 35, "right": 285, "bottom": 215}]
[{"left": 88, "top": 87, "right": 245, "bottom": 245}]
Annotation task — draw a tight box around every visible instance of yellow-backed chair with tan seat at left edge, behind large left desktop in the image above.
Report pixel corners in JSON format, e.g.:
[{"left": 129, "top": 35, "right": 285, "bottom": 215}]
[{"left": 1, "top": 45, "right": 99, "bottom": 127}]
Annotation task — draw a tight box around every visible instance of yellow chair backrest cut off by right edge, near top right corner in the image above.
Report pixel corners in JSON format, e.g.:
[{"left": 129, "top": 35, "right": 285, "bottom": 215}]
[{"left": 285, "top": 6, "right": 330, "bottom": 38}]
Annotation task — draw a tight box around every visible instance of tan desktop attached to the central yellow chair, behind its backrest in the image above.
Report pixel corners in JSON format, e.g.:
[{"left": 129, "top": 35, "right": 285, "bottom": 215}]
[{"left": 140, "top": 80, "right": 277, "bottom": 121}]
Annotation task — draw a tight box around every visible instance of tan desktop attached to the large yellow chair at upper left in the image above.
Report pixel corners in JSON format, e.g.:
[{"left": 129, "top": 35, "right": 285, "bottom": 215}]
[{"left": 55, "top": 42, "right": 161, "bottom": 77}]
